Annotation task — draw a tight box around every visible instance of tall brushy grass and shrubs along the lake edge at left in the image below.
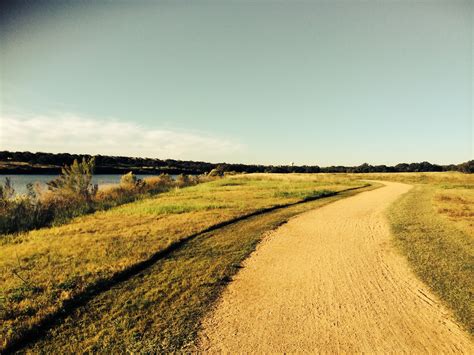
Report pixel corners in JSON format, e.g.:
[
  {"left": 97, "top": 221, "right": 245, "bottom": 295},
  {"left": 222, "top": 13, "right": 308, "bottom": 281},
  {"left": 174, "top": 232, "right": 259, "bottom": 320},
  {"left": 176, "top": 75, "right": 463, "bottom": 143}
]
[{"left": 0, "top": 160, "right": 211, "bottom": 235}]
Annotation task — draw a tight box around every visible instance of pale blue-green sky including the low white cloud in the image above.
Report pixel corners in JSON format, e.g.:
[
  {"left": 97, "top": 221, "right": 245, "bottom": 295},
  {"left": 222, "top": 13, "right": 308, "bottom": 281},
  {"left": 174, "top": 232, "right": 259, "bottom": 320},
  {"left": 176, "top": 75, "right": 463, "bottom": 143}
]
[{"left": 0, "top": 0, "right": 474, "bottom": 166}]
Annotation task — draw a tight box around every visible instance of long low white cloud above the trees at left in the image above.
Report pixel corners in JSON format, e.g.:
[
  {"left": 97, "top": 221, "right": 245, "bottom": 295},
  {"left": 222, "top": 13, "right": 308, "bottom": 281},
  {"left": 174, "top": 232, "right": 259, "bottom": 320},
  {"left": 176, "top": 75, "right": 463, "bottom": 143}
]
[{"left": 0, "top": 114, "right": 243, "bottom": 161}]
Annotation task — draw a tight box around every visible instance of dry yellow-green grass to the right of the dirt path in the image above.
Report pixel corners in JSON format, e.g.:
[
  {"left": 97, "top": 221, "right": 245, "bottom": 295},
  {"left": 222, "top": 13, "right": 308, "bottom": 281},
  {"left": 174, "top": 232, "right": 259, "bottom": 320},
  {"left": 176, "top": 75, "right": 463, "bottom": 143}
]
[{"left": 359, "top": 173, "right": 474, "bottom": 334}]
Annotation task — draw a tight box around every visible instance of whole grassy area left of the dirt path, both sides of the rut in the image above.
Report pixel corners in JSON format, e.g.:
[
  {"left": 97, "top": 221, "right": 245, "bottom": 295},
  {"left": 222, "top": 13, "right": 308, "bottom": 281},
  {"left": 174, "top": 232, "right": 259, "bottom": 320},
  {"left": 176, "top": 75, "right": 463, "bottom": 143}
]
[{"left": 0, "top": 174, "right": 363, "bottom": 350}]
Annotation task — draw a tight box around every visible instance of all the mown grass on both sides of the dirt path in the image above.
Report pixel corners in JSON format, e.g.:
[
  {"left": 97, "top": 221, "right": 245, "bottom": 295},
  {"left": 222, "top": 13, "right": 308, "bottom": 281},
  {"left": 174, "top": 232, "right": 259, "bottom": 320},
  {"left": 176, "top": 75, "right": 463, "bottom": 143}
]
[{"left": 0, "top": 173, "right": 474, "bottom": 352}]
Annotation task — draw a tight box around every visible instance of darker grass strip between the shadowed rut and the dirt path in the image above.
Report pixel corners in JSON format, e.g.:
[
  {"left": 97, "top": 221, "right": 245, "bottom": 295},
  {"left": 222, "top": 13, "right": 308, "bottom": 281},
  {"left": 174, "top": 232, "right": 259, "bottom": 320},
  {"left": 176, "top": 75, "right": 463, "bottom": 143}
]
[{"left": 19, "top": 182, "right": 378, "bottom": 353}]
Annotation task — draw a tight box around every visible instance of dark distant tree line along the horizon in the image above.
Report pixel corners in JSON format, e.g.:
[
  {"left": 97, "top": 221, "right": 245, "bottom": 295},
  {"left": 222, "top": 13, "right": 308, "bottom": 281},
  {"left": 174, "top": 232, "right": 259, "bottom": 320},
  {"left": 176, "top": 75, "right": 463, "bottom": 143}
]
[{"left": 0, "top": 151, "right": 474, "bottom": 174}]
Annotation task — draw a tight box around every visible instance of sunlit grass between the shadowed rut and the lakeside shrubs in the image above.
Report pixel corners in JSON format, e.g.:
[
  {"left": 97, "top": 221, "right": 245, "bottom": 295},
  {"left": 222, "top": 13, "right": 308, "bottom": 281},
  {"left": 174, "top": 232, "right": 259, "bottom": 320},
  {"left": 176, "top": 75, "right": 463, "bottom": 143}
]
[{"left": 0, "top": 174, "right": 363, "bottom": 348}]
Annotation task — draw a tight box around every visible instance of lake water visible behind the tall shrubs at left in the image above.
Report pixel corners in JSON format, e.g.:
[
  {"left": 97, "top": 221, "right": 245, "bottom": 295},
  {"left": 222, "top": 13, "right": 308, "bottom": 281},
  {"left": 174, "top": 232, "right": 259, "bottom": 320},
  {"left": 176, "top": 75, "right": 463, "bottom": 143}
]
[{"left": 0, "top": 174, "right": 176, "bottom": 194}]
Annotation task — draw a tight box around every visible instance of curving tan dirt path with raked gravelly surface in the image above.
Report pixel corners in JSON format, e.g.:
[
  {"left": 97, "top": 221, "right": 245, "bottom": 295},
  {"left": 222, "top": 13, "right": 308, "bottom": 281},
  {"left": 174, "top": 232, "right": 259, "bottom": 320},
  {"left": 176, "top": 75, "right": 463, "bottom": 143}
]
[{"left": 199, "top": 182, "right": 474, "bottom": 353}]
